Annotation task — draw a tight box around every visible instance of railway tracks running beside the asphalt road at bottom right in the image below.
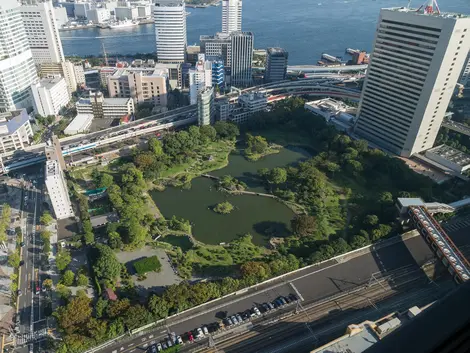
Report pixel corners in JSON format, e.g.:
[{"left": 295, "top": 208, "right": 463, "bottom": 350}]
[{"left": 199, "top": 264, "right": 456, "bottom": 353}]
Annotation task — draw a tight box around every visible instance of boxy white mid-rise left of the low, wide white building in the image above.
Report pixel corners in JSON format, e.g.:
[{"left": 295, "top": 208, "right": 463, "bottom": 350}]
[{"left": 31, "top": 76, "right": 70, "bottom": 116}]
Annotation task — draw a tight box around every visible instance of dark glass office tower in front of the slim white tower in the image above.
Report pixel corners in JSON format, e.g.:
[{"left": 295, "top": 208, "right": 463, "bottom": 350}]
[{"left": 230, "top": 32, "right": 253, "bottom": 87}]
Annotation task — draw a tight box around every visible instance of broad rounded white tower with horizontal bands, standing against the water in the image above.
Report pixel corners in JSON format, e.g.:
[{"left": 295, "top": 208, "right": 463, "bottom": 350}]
[{"left": 153, "top": 0, "right": 186, "bottom": 63}]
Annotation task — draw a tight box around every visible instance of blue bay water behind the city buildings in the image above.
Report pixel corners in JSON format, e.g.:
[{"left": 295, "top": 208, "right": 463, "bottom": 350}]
[{"left": 60, "top": 0, "right": 470, "bottom": 65}]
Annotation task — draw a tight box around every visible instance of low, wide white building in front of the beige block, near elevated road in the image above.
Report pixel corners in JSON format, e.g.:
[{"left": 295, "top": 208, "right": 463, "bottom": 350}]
[{"left": 75, "top": 92, "right": 134, "bottom": 119}]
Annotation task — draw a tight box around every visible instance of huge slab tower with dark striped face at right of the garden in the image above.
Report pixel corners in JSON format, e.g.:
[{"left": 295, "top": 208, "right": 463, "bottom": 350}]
[{"left": 354, "top": 0, "right": 470, "bottom": 157}]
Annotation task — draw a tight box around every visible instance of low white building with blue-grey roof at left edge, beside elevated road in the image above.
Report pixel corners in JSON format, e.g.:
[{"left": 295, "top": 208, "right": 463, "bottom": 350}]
[{"left": 0, "top": 109, "right": 33, "bottom": 154}]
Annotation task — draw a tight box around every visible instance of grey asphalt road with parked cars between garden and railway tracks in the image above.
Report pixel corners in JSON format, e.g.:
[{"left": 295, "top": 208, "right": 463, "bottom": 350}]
[{"left": 101, "top": 227, "right": 456, "bottom": 353}]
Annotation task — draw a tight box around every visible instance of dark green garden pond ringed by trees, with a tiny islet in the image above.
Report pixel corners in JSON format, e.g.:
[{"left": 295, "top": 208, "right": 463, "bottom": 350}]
[{"left": 152, "top": 147, "right": 309, "bottom": 245}]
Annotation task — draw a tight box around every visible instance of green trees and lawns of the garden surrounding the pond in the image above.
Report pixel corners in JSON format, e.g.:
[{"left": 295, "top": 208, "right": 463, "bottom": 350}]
[{"left": 53, "top": 98, "right": 470, "bottom": 353}]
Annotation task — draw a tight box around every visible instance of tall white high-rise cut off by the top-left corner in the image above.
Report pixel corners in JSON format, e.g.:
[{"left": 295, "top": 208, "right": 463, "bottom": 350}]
[{"left": 0, "top": 0, "right": 38, "bottom": 113}]
